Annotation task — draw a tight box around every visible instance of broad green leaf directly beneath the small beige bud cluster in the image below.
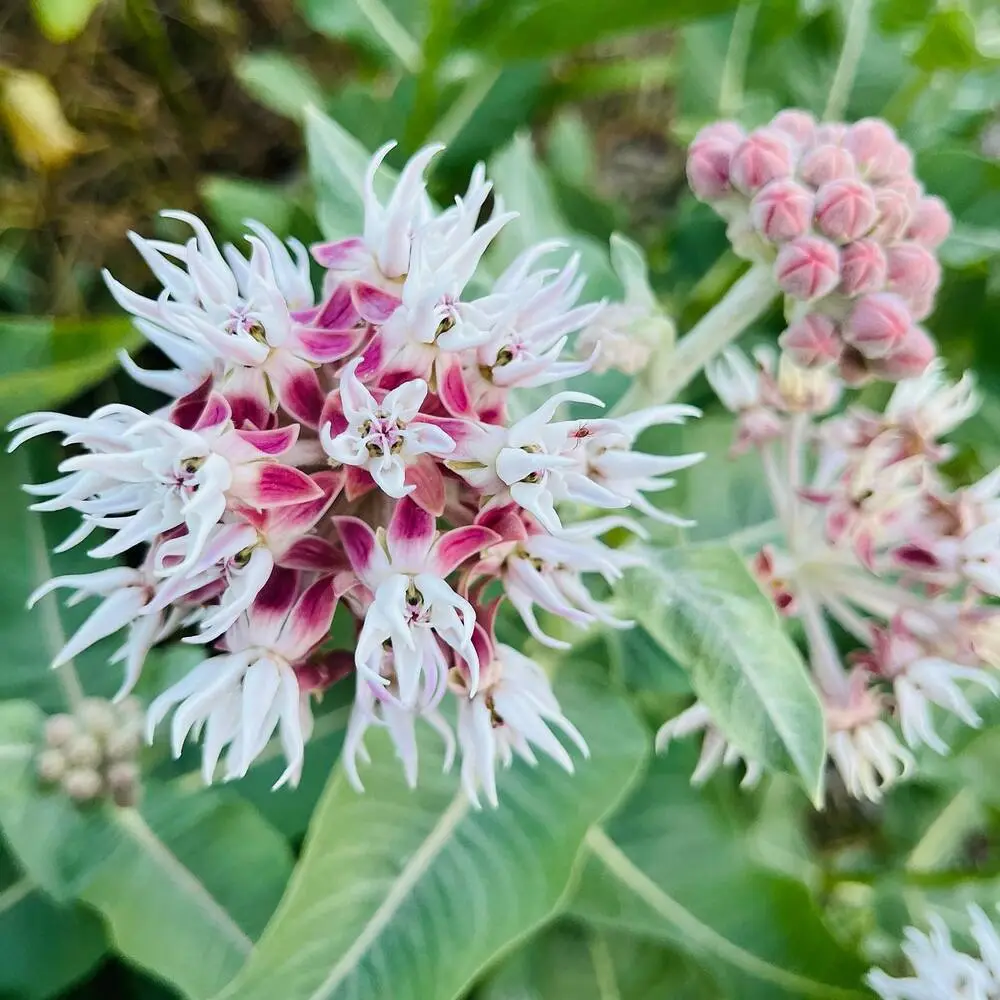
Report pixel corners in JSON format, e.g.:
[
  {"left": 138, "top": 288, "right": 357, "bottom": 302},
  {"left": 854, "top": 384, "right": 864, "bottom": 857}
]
[{"left": 0, "top": 702, "right": 291, "bottom": 998}]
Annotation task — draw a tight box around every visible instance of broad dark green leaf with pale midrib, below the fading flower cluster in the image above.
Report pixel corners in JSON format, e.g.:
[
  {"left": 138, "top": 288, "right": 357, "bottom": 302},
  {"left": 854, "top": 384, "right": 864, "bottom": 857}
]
[{"left": 570, "top": 744, "right": 869, "bottom": 1000}]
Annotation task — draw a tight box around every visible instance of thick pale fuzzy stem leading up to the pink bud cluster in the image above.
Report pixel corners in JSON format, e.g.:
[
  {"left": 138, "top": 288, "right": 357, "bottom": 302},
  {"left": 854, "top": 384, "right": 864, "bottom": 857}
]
[{"left": 613, "top": 263, "right": 778, "bottom": 416}]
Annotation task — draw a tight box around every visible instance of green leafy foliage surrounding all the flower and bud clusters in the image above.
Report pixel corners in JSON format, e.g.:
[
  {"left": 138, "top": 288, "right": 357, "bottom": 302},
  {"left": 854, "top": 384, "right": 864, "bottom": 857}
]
[{"left": 0, "top": 0, "right": 1000, "bottom": 1000}]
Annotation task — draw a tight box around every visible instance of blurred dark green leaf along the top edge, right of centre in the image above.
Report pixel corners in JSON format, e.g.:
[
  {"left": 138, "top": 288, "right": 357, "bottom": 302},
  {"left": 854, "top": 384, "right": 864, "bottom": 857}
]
[{"left": 456, "top": 0, "right": 738, "bottom": 59}]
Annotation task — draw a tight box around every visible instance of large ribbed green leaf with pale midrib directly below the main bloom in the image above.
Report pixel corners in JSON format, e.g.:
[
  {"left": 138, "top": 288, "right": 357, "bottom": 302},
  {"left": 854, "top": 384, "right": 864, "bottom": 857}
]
[{"left": 211, "top": 684, "right": 647, "bottom": 1000}]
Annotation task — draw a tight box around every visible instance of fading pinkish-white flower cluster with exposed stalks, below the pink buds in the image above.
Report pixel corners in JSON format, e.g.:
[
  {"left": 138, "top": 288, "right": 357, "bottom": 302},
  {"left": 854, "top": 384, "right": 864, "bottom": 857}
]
[{"left": 662, "top": 351, "right": 1000, "bottom": 800}]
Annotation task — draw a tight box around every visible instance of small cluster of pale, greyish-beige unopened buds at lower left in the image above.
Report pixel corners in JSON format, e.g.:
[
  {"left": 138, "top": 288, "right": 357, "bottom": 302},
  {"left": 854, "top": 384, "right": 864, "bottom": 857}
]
[{"left": 35, "top": 698, "right": 142, "bottom": 806}]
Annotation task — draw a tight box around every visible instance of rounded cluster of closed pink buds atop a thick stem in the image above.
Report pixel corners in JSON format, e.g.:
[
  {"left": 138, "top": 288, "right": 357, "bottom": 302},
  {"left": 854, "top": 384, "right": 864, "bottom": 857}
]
[{"left": 687, "top": 111, "right": 951, "bottom": 384}]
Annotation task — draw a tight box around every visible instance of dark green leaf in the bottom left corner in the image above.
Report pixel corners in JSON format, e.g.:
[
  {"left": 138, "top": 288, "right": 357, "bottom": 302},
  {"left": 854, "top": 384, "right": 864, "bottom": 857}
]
[{"left": 0, "top": 876, "right": 107, "bottom": 1000}]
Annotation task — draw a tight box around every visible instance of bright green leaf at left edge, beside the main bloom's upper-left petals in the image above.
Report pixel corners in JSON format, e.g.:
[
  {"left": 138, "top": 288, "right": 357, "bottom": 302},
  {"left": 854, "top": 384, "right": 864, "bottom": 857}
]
[{"left": 0, "top": 316, "right": 142, "bottom": 422}]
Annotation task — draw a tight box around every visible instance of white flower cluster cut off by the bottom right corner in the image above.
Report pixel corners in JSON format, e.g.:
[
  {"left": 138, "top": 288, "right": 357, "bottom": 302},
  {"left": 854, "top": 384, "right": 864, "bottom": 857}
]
[{"left": 868, "top": 905, "right": 1000, "bottom": 1000}]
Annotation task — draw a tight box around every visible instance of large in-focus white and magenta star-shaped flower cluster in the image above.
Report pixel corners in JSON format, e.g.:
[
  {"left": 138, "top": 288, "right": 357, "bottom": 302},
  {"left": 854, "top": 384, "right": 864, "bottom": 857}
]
[{"left": 12, "top": 144, "right": 701, "bottom": 803}]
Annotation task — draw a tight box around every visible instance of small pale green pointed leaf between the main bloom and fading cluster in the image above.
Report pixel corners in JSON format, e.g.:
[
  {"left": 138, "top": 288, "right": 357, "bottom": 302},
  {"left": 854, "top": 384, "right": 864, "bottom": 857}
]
[{"left": 622, "top": 545, "right": 826, "bottom": 802}]
